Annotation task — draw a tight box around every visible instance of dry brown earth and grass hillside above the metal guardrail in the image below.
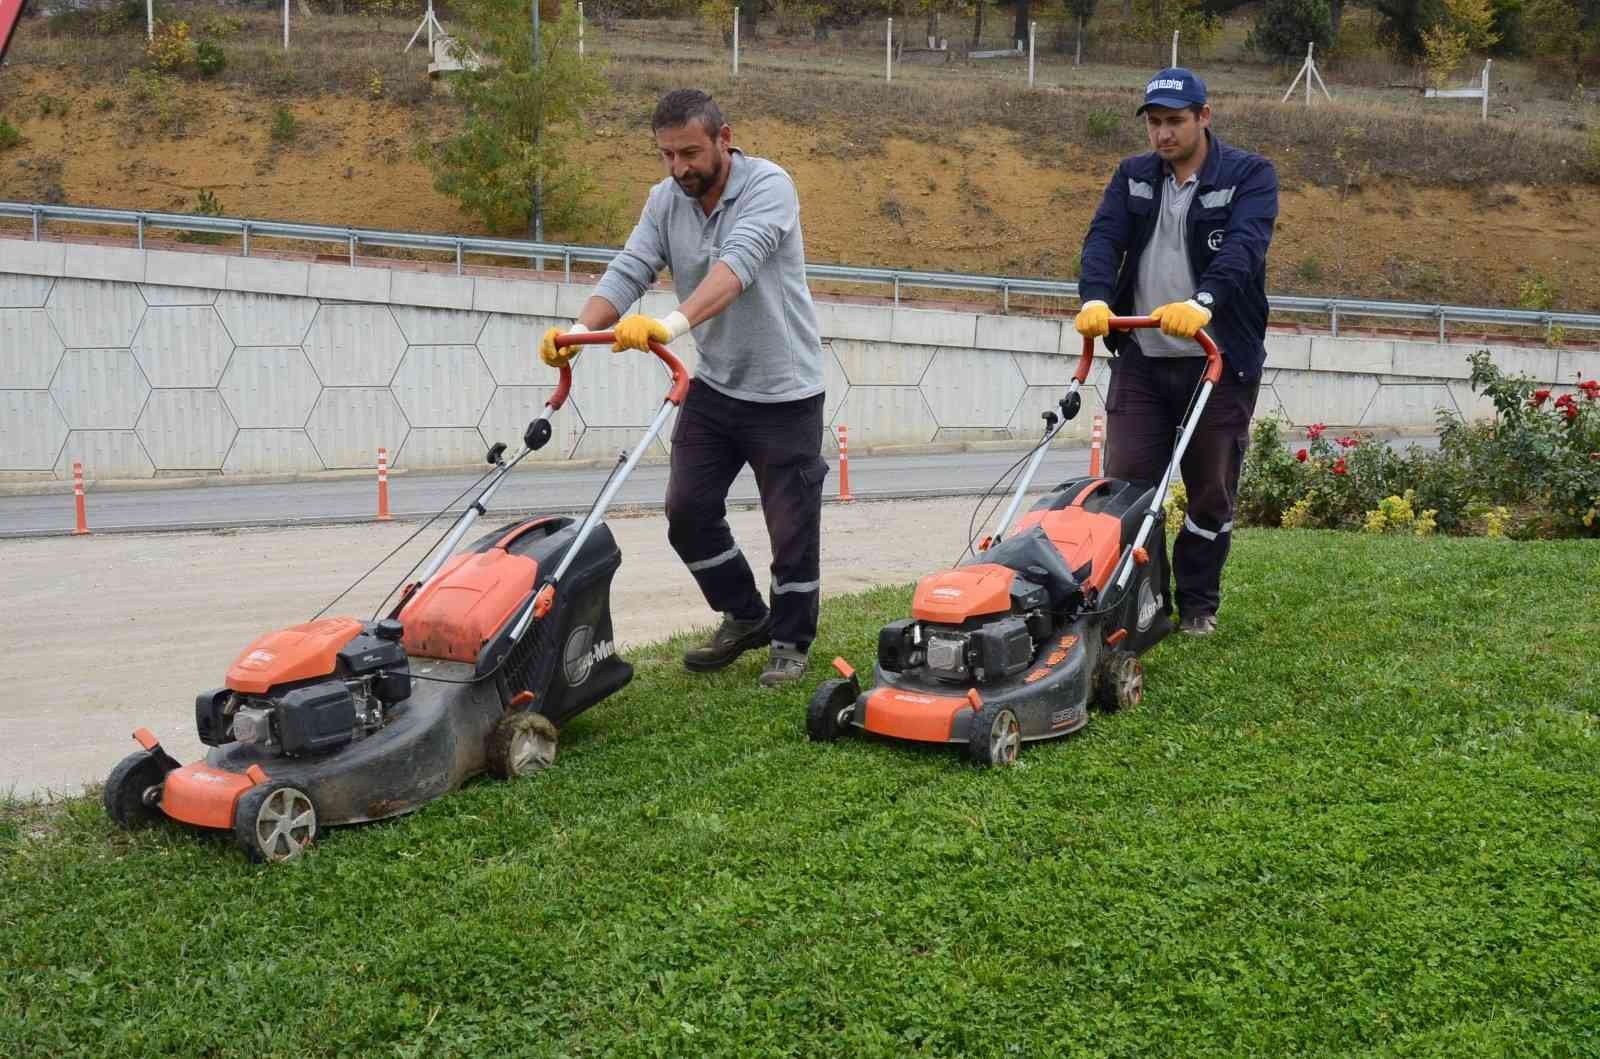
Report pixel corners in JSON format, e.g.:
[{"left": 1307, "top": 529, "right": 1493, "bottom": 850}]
[{"left": 0, "top": 6, "right": 1600, "bottom": 310}]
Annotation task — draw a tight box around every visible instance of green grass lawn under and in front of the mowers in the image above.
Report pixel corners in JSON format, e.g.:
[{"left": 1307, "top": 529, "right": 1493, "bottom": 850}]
[{"left": 0, "top": 530, "right": 1600, "bottom": 1057}]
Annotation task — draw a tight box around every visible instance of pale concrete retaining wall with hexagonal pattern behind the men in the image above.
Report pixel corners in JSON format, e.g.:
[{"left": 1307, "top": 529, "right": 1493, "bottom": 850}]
[{"left": 0, "top": 240, "right": 1600, "bottom": 478}]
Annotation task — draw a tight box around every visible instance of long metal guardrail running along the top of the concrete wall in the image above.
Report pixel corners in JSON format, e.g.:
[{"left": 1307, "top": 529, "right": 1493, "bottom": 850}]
[{"left": 0, "top": 202, "right": 1600, "bottom": 341}]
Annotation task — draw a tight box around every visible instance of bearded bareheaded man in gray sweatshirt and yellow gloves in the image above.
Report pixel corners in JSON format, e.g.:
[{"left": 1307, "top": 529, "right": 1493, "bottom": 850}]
[{"left": 539, "top": 88, "right": 827, "bottom": 686}]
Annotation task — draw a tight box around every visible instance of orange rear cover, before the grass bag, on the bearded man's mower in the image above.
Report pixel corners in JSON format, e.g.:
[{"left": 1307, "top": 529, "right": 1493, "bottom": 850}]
[{"left": 400, "top": 547, "right": 539, "bottom": 662}]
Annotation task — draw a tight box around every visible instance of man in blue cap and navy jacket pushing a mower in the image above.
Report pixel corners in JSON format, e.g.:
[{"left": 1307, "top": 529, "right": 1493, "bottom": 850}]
[{"left": 1077, "top": 67, "right": 1278, "bottom": 635}]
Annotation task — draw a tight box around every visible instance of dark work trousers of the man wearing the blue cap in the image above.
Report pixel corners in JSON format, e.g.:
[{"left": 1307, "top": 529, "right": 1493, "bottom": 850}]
[{"left": 1106, "top": 350, "right": 1261, "bottom": 617}]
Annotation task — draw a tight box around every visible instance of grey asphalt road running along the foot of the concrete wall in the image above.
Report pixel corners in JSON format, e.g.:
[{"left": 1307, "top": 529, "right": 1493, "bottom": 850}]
[{"left": 0, "top": 443, "right": 1090, "bottom": 537}]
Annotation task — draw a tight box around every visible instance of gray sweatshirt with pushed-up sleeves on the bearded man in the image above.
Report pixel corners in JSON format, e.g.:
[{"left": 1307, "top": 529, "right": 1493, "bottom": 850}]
[{"left": 594, "top": 150, "right": 824, "bottom": 403}]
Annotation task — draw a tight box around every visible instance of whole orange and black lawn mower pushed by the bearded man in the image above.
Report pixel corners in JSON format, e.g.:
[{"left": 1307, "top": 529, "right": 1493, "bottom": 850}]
[{"left": 102, "top": 331, "right": 688, "bottom": 861}]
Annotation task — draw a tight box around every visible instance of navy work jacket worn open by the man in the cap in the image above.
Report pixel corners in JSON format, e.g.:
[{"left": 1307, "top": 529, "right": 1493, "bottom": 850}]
[{"left": 1078, "top": 130, "right": 1278, "bottom": 382}]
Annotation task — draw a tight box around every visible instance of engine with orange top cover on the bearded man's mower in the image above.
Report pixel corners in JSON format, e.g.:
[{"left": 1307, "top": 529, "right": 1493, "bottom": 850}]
[{"left": 195, "top": 617, "right": 411, "bottom": 757}]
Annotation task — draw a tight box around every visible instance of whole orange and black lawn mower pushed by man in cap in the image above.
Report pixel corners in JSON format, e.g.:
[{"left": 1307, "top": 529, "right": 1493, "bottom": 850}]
[{"left": 806, "top": 317, "right": 1222, "bottom": 766}]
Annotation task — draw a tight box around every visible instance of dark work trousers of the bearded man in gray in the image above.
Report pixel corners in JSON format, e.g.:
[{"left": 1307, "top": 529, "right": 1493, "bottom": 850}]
[{"left": 667, "top": 379, "right": 827, "bottom": 651}]
